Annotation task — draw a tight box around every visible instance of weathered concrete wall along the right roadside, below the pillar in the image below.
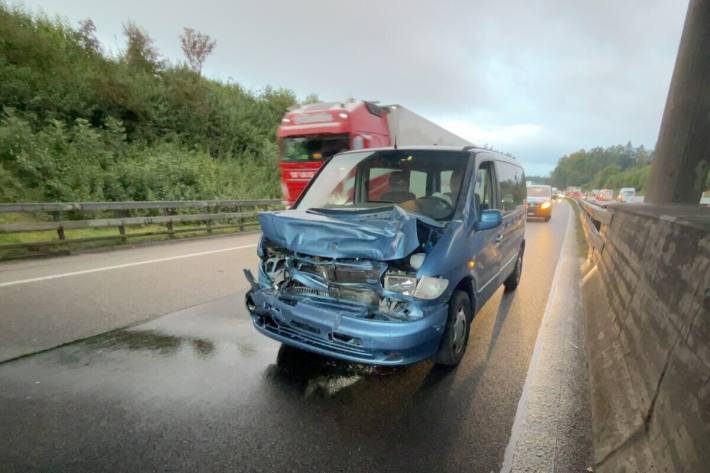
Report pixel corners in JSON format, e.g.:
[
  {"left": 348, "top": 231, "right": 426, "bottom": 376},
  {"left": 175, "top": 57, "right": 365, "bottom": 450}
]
[{"left": 582, "top": 204, "right": 710, "bottom": 472}]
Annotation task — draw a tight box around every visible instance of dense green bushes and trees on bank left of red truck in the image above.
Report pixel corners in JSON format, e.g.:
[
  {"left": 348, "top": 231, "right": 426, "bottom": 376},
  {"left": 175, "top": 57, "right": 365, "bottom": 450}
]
[{"left": 0, "top": 3, "right": 295, "bottom": 201}]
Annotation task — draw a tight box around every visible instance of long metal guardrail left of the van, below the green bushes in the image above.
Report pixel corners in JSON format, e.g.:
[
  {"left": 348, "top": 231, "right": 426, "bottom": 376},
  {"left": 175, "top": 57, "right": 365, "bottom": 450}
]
[{"left": 0, "top": 199, "right": 282, "bottom": 250}]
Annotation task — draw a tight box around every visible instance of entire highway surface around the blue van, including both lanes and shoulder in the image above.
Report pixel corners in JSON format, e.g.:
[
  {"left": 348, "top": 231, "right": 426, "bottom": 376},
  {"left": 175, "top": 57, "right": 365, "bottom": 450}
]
[{"left": 0, "top": 203, "right": 591, "bottom": 473}]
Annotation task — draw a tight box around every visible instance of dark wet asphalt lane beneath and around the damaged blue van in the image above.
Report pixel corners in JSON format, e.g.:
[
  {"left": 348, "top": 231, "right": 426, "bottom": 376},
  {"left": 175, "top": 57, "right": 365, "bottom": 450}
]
[{"left": 0, "top": 204, "right": 589, "bottom": 472}]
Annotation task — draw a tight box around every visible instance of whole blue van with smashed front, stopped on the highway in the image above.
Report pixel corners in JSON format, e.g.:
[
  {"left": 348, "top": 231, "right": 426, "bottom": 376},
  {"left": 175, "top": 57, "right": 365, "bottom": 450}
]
[{"left": 245, "top": 147, "right": 526, "bottom": 365}]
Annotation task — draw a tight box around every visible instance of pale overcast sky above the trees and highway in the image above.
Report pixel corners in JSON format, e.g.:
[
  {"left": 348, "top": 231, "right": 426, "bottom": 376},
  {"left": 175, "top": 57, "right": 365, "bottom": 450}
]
[{"left": 24, "top": 0, "right": 688, "bottom": 174}]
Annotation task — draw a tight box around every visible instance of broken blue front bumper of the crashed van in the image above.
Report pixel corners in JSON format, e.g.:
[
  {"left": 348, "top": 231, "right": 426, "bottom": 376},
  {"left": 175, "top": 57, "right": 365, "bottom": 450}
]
[{"left": 247, "top": 287, "right": 448, "bottom": 365}]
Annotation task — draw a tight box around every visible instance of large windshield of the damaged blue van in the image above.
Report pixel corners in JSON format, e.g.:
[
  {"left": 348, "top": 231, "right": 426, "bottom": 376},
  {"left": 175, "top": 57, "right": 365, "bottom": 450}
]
[{"left": 297, "top": 150, "right": 469, "bottom": 220}]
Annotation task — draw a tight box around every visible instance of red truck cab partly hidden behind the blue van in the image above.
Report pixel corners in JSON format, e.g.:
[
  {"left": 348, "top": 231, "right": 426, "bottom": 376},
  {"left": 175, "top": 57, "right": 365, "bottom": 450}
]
[{"left": 278, "top": 100, "right": 390, "bottom": 207}]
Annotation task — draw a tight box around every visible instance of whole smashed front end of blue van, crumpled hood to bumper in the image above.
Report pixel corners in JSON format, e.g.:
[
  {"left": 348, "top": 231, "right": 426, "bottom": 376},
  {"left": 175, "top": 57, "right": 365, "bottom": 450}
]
[{"left": 245, "top": 205, "right": 449, "bottom": 365}]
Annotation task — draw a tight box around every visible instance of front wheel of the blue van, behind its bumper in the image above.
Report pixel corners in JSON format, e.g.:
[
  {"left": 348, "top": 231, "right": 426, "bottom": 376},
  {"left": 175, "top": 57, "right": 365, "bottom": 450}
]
[{"left": 432, "top": 290, "right": 473, "bottom": 366}]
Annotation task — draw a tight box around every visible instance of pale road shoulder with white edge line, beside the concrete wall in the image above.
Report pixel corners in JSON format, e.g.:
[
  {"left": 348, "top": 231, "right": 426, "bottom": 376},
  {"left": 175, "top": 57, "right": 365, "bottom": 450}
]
[{"left": 501, "top": 201, "right": 592, "bottom": 472}]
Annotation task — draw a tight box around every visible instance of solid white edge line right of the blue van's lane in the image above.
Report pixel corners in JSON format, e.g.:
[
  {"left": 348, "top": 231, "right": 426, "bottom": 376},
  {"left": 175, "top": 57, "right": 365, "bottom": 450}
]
[{"left": 500, "top": 205, "right": 572, "bottom": 473}]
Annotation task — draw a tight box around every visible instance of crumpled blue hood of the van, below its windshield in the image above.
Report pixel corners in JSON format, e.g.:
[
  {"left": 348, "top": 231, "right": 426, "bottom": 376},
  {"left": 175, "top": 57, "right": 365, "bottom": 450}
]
[{"left": 259, "top": 206, "right": 428, "bottom": 261}]
